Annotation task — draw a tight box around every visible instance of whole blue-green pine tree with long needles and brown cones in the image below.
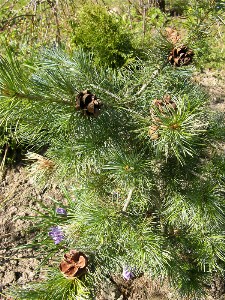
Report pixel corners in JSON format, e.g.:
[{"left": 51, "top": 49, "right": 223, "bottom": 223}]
[{"left": 0, "top": 42, "right": 225, "bottom": 300}]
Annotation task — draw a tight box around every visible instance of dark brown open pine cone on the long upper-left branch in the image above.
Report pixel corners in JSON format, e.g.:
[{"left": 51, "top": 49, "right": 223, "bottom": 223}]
[{"left": 76, "top": 90, "right": 102, "bottom": 117}]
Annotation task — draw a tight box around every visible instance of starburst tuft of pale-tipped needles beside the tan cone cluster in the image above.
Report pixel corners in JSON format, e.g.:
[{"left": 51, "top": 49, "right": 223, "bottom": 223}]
[{"left": 135, "top": 96, "right": 207, "bottom": 163}]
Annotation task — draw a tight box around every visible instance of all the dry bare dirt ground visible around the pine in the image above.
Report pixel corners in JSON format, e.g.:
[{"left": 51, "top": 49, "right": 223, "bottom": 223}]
[{"left": 0, "top": 70, "right": 225, "bottom": 300}]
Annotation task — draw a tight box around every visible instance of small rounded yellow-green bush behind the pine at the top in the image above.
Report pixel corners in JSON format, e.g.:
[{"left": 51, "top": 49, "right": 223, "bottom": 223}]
[{"left": 72, "top": 4, "right": 135, "bottom": 67}]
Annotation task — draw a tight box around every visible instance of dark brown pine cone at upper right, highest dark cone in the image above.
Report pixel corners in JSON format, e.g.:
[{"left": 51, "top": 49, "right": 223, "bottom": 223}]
[{"left": 168, "top": 45, "right": 194, "bottom": 67}]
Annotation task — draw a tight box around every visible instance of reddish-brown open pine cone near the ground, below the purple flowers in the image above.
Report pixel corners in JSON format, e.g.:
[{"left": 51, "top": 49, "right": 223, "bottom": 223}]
[{"left": 59, "top": 250, "right": 88, "bottom": 277}]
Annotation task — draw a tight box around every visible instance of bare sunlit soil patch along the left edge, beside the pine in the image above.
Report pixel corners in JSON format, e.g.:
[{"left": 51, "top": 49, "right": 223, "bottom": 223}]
[{"left": 0, "top": 165, "right": 62, "bottom": 299}]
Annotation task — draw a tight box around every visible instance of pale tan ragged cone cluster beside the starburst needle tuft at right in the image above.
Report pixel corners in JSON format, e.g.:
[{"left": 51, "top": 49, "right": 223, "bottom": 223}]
[{"left": 148, "top": 95, "right": 177, "bottom": 140}]
